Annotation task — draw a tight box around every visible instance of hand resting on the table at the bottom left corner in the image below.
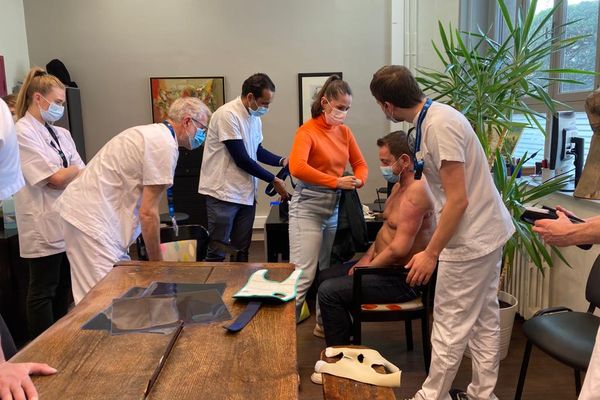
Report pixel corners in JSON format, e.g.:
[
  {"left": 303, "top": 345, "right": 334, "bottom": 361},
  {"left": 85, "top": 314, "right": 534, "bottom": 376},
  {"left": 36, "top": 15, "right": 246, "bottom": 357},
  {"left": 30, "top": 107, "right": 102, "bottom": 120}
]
[{"left": 0, "top": 362, "right": 56, "bottom": 400}]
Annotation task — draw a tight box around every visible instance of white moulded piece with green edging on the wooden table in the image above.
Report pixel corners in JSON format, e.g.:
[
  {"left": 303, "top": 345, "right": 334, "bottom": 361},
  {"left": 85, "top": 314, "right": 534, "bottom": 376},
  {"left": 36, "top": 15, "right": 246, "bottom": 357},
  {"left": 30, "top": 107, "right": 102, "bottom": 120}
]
[{"left": 233, "top": 269, "right": 302, "bottom": 301}]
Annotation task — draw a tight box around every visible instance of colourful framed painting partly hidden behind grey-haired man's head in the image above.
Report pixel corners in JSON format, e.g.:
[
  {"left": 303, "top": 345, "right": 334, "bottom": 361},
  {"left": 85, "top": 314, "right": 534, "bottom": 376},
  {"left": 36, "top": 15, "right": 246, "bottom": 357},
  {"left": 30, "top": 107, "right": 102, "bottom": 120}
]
[{"left": 150, "top": 76, "right": 225, "bottom": 123}]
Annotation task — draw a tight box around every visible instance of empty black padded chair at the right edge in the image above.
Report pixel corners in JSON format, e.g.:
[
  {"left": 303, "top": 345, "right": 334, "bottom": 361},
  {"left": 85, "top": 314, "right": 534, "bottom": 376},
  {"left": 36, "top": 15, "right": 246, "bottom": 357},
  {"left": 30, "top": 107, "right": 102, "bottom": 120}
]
[{"left": 515, "top": 256, "right": 600, "bottom": 400}]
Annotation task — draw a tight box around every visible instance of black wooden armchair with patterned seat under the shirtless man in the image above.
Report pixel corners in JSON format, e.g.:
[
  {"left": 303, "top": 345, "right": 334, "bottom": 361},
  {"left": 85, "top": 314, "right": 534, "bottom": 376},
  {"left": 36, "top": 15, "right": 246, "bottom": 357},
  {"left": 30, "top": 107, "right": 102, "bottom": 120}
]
[{"left": 352, "top": 267, "right": 435, "bottom": 374}]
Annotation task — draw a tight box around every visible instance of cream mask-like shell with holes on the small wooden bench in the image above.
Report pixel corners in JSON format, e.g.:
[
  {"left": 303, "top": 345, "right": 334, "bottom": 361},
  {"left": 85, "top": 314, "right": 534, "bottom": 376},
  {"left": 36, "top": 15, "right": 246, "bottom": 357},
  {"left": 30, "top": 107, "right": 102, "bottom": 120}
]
[{"left": 311, "top": 347, "right": 402, "bottom": 387}]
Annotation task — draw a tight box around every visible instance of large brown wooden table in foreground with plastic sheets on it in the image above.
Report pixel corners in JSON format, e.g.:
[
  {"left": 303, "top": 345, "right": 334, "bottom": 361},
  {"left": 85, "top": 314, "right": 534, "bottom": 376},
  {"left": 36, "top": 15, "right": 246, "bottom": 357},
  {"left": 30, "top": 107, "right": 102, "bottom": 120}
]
[{"left": 11, "top": 261, "right": 298, "bottom": 399}]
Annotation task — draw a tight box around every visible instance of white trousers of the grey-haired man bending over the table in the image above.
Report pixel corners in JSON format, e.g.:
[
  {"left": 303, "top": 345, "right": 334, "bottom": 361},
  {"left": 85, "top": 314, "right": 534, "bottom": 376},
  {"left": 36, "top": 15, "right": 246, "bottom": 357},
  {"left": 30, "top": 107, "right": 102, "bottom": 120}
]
[{"left": 64, "top": 221, "right": 129, "bottom": 304}]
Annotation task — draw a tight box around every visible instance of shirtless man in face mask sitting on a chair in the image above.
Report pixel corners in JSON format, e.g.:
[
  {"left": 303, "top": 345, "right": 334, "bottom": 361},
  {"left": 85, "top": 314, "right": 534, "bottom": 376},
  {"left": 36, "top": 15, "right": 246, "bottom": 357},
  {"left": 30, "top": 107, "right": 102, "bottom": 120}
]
[{"left": 315, "top": 131, "right": 435, "bottom": 346}]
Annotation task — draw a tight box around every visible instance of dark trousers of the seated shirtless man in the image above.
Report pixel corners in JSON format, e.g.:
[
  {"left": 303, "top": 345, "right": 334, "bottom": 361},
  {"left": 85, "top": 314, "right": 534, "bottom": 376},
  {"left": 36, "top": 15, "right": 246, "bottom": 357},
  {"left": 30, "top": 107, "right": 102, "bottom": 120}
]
[{"left": 318, "top": 262, "right": 419, "bottom": 346}]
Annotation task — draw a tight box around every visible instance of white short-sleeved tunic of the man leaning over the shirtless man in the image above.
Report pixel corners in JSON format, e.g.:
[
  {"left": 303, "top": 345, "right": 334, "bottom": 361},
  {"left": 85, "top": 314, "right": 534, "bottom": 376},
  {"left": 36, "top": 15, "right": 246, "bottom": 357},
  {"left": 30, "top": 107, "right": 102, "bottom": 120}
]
[{"left": 413, "top": 102, "right": 515, "bottom": 261}]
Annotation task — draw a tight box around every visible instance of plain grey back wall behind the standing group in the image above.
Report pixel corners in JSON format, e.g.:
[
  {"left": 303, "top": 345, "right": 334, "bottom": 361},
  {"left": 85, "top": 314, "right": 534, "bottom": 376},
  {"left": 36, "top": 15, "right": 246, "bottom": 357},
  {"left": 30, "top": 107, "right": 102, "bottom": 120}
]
[{"left": 24, "top": 0, "right": 390, "bottom": 222}]
